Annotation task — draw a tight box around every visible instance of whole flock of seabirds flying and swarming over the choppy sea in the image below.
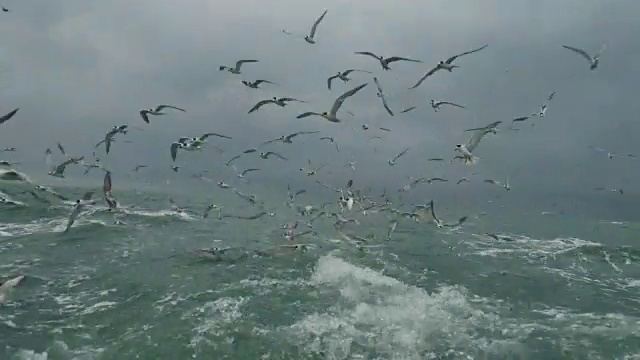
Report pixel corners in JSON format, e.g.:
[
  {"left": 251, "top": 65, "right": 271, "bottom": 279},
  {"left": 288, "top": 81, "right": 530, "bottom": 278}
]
[{"left": 0, "top": 8, "right": 635, "bottom": 302}]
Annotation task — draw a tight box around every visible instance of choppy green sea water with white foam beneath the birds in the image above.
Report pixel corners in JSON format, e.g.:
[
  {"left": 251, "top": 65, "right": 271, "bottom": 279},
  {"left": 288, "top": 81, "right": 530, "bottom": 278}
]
[{"left": 0, "top": 178, "right": 640, "bottom": 360}]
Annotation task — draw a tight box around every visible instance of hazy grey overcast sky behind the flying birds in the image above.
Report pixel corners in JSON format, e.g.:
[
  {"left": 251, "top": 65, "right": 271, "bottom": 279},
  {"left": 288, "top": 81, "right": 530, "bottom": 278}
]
[{"left": 0, "top": 0, "right": 640, "bottom": 200}]
